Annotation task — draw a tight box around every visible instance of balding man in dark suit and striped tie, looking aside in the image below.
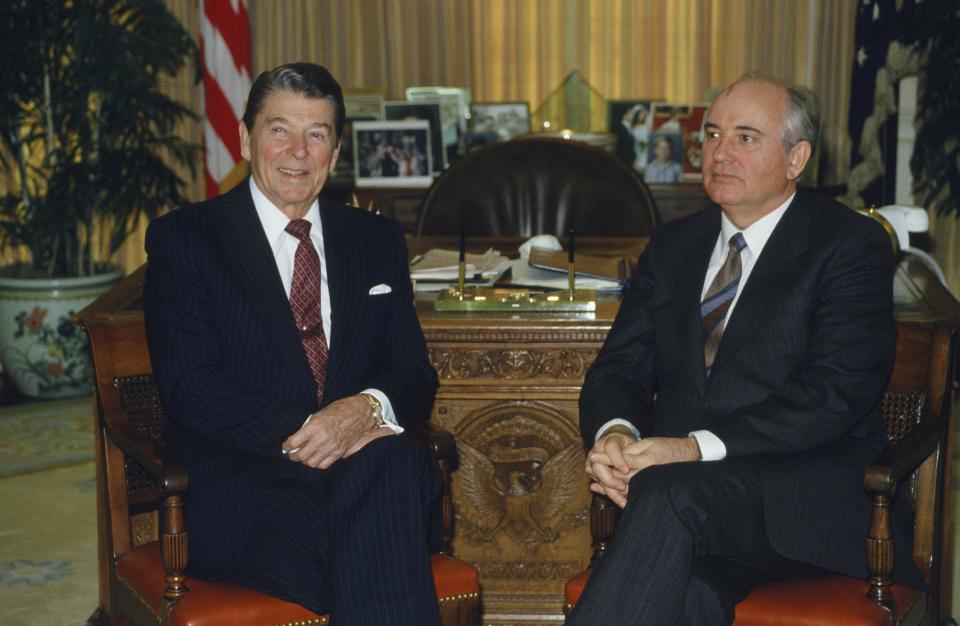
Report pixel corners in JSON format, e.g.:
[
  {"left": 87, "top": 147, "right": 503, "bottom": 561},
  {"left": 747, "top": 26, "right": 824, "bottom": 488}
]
[{"left": 567, "top": 77, "right": 915, "bottom": 626}]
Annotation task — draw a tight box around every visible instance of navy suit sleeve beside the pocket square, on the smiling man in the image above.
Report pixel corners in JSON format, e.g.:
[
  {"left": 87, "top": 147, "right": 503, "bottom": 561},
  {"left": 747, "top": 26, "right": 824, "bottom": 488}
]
[{"left": 358, "top": 222, "right": 437, "bottom": 428}]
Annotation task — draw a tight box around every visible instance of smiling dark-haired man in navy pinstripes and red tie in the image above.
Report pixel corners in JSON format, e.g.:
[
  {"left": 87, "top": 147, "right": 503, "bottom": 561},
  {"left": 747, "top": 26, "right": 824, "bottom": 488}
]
[{"left": 144, "top": 63, "right": 440, "bottom": 626}]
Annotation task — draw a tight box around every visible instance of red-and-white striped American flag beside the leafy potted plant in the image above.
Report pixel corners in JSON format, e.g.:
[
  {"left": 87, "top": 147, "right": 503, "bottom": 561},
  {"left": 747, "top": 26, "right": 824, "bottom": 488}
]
[{"left": 200, "top": 0, "right": 251, "bottom": 198}]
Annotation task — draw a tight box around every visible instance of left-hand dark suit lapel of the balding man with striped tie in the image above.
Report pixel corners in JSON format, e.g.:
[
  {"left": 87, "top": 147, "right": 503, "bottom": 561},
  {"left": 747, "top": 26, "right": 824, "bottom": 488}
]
[{"left": 673, "top": 206, "right": 720, "bottom": 392}]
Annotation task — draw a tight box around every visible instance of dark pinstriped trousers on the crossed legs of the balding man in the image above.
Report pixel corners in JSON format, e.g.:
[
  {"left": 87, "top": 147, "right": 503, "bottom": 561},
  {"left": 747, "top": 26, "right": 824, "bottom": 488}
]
[{"left": 566, "top": 459, "right": 823, "bottom": 626}]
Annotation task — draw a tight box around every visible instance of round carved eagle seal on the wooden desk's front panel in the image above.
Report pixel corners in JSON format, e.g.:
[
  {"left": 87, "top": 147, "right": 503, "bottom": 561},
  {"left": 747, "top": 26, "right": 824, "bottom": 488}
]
[{"left": 456, "top": 402, "right": 588, "bottom": 552}]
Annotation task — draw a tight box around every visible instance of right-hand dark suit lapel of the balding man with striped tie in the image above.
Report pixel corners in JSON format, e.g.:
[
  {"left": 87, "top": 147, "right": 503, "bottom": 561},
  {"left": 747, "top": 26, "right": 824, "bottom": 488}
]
[{"left": 713, "top": 192, "right": 814, "bottom": 371}]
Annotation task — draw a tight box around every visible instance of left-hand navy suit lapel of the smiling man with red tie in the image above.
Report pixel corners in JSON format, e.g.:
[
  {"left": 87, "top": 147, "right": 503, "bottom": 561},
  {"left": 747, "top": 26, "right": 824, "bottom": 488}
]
[{"left": 217, "top": 179, "right": 316, "bottom": 395}]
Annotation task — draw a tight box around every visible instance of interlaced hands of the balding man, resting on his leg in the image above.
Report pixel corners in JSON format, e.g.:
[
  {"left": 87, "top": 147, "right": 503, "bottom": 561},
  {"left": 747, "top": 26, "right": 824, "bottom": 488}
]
[{"left": 586, "top": 432, "right": 700, "bottom": 509}]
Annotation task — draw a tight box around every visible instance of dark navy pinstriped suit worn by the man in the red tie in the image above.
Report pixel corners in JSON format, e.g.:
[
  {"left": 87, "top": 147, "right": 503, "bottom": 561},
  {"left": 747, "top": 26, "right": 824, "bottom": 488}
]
[{"left": 144, "top": 181, "right": 439, "bottom": 625}]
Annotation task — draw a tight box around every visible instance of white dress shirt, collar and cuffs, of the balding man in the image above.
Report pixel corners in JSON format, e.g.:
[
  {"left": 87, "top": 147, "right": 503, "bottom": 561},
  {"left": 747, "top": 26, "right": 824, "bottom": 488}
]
[{"left": 596, "top": 193, "right": 796, "bottom": 461}]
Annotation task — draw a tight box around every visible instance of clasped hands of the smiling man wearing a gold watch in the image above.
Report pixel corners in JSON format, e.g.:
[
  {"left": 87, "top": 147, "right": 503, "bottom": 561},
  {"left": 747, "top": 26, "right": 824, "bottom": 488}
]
[{"left": 283, "top": 396, "right": 394, "bottom": 469}]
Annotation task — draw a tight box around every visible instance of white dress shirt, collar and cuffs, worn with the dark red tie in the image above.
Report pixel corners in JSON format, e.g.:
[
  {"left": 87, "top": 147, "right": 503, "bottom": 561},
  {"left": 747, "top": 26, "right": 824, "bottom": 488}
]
[{"left": 250, "top": 176, "right": 403, "bottom": 433}]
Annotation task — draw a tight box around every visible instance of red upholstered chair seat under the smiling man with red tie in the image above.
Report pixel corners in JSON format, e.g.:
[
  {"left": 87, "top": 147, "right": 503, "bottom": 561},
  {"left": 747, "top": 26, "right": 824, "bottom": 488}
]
[{"left": 116, "top": 541, "right": 479, "bottom": 626}]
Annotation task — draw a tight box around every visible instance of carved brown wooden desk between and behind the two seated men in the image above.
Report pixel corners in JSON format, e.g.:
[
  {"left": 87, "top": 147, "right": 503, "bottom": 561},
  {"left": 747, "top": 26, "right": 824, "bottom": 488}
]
[{"left": 81, "top": 239, "right": 960, "bottom": 626}]
